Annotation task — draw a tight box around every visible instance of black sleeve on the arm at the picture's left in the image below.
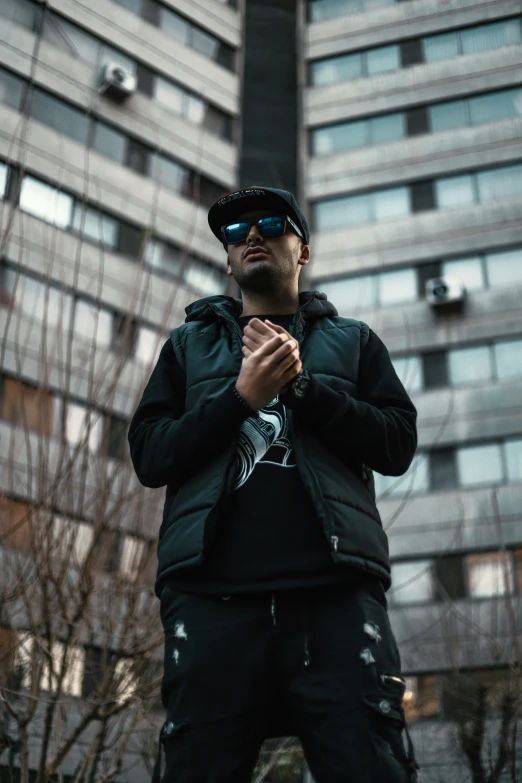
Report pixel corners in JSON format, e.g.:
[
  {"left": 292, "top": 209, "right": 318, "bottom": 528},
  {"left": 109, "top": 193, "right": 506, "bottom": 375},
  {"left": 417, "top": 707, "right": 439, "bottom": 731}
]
[{"left": 128, "top": 340, "right": 253, "bottom": 487}]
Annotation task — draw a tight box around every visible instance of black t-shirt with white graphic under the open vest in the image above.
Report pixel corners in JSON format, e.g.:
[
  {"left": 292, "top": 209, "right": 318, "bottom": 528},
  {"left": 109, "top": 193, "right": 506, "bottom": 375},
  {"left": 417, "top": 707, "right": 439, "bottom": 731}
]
[{"left": 178, "top": 315, "right": 348, "bottom": 595}]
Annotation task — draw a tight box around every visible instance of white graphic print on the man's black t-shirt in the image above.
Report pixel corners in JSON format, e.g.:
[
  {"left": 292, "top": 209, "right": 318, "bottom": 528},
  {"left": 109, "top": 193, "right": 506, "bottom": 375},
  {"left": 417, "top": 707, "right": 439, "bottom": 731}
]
[{"left": 233, "top": 397, "right": 296, "bottom": 489}]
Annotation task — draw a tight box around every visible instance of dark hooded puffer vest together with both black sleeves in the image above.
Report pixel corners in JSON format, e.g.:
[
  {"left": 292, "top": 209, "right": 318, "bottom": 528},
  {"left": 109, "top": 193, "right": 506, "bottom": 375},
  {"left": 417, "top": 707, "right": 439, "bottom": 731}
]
[{"left": 129, "top": 291, "right": 417, "bottom": 595}]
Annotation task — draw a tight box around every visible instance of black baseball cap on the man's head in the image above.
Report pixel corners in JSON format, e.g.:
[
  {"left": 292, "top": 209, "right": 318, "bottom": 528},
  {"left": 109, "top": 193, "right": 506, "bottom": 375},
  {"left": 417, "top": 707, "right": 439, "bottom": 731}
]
[{"left": 208, "top": 185, "right": 310, "bottom": 249}]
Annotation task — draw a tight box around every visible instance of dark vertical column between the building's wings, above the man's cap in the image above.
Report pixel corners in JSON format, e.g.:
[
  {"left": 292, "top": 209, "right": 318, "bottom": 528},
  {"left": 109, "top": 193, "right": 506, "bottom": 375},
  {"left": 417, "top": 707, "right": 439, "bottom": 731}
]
[{"left": 239, "top": 0, "right": 298, "bottom": 195}]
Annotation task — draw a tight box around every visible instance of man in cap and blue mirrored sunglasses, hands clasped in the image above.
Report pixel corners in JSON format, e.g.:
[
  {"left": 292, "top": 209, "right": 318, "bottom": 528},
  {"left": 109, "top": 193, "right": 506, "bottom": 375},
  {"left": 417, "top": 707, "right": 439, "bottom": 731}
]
[{"left": 129, "top": 187, "right": 418, "bottom": 783}]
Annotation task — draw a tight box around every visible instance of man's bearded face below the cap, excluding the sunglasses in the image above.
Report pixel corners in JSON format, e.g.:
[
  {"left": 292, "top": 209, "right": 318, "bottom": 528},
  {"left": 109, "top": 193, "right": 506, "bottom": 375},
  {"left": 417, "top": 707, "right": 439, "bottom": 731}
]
[{"left": 227, "top": 209, "right": 310, "bottom": 294}]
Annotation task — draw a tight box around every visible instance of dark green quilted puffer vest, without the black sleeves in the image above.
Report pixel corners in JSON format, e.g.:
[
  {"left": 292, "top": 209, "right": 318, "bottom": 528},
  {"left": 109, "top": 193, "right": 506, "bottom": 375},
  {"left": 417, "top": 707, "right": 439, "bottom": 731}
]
[{"left": 156, "top": 291, "right": 390, "bottom": 589}]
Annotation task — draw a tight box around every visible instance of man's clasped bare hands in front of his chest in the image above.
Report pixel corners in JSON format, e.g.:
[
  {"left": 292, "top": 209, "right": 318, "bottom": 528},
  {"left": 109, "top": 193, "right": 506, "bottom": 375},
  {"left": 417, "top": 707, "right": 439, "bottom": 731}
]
[{"left": 236, "top": 318, "right": 303, "bottom": 410}]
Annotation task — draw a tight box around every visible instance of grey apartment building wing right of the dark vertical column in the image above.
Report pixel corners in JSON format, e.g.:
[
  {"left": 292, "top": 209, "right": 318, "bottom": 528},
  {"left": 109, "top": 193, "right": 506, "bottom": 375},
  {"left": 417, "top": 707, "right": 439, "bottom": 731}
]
[{"left": 303, "top": 0, "right": 522, "bottom": 781}]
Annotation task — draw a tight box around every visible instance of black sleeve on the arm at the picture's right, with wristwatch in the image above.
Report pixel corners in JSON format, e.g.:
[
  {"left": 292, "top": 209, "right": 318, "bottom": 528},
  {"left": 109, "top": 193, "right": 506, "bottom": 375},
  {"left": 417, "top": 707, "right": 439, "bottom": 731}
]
[{"left": 285, "top": 329, "right": 417, "bottom": 476}]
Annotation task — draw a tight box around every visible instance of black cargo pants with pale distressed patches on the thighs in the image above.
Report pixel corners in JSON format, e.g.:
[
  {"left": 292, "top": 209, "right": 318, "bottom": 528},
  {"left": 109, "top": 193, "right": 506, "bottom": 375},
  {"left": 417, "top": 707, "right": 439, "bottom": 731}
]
[{"left": 156, "top": 580, "right": 419, "bottom": 783}]
